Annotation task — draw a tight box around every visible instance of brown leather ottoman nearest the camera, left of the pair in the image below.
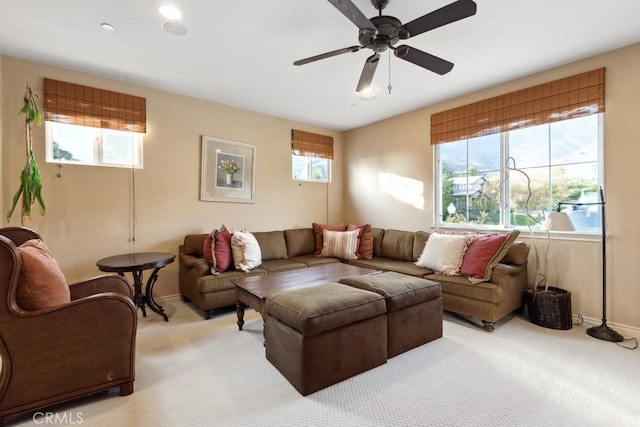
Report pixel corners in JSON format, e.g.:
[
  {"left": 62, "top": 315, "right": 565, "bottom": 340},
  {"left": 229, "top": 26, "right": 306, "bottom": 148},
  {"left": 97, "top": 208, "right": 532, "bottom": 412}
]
[{"left": 264, "top": 282, "right": 387, "bottom": 396}]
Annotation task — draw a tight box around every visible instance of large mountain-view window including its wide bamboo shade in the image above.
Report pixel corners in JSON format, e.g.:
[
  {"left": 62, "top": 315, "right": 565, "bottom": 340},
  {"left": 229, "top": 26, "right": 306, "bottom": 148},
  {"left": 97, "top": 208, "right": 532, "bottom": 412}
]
[{"left": 431, "top": 68, "right": 605, "bottom": 232}]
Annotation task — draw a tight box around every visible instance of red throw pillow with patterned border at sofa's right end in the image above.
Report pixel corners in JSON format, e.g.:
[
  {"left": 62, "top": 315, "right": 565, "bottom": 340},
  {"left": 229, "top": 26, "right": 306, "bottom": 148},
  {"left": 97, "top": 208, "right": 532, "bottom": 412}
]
[{"left": 460, "top": 234, "right": 510, "bottom": 280}]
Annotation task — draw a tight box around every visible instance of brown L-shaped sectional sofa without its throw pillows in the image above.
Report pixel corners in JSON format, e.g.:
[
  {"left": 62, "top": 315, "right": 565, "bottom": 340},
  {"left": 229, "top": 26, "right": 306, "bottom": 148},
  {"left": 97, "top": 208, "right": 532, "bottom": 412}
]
[{"left": 178, "top": 227, "right": 529, "bottom": 331}]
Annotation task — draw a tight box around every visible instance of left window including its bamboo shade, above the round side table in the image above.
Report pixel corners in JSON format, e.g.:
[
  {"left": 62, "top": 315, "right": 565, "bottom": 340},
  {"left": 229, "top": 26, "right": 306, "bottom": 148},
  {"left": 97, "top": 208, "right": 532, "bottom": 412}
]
[{"left": 44, "top": 79, "right": 147, "bottom": 168}]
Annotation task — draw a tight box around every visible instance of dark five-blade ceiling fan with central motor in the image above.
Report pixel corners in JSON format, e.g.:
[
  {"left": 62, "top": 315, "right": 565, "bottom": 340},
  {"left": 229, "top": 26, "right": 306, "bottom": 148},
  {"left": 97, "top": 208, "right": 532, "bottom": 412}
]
[{"left": 293, "top": 0, "right": 476, "bottom": 92}]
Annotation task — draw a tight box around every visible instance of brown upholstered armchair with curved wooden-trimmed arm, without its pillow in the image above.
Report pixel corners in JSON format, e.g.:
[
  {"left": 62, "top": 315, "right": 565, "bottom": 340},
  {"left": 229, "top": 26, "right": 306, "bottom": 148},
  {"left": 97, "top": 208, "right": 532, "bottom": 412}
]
[{"left": 0, "top": 227, "right": 138, "bottom": 422}]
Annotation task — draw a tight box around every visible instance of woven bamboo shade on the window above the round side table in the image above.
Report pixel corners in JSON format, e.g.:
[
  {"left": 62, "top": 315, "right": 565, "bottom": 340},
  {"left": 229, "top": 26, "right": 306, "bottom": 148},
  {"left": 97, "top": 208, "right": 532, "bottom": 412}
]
[{"left": 44, "top": 79, "right": 147, "bottom": 133}]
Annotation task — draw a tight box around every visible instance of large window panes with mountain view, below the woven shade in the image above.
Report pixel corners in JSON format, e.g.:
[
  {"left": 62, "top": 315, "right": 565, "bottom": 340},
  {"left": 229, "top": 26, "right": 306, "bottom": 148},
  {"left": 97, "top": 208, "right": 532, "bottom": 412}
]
[{"left": 435, "top": 113, "right": 603, "bottom": 232}]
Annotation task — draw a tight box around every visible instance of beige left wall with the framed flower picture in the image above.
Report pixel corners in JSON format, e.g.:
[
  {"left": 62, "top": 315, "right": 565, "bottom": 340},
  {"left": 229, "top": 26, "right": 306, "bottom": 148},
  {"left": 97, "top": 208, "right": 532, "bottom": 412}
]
[{"left": 0, "top": 56, "right": 343, "bottom": 296}]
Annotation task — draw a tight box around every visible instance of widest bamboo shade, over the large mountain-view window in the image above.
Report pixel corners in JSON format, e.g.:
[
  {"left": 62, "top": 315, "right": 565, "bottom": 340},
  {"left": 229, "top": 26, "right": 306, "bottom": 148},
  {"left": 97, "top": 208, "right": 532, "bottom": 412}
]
[{"left": 431, "top": 68, "right": 605, "bottom": 145}]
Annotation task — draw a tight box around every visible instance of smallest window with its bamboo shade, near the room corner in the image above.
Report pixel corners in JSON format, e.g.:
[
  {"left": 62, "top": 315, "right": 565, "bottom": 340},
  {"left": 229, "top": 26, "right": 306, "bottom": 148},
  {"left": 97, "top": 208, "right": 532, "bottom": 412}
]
[{"left": 291, "top": 129, "right": 333, "bottom": 182}]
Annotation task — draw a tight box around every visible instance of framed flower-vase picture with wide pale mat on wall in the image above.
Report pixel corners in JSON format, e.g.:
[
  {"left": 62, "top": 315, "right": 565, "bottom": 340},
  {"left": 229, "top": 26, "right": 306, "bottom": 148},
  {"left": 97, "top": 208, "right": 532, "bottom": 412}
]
[{"left": 200, "top": 135, "right": 256, "bottom": 203}]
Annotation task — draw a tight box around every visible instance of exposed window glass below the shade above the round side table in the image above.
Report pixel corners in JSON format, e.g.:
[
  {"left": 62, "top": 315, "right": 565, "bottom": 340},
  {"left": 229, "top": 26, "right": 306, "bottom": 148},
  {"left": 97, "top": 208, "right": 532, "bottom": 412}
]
[{"left": 45, "top": 122, "right": 143, "bottom": 168}]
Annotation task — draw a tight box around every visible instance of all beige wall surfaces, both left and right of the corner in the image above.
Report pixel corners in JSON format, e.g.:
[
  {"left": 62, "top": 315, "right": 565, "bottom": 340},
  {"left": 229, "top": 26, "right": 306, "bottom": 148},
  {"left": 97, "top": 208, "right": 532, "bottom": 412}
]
[{"left": 5, "top": 45, "right": 640, "bottom": 328}]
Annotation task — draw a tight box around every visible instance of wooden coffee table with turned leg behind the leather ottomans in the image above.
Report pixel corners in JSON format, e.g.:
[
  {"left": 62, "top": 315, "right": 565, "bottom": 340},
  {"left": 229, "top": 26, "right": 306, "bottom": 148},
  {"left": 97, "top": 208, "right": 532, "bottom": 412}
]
[{"left": 231, "top": 262, "right": 380, "bottom": 330}]
